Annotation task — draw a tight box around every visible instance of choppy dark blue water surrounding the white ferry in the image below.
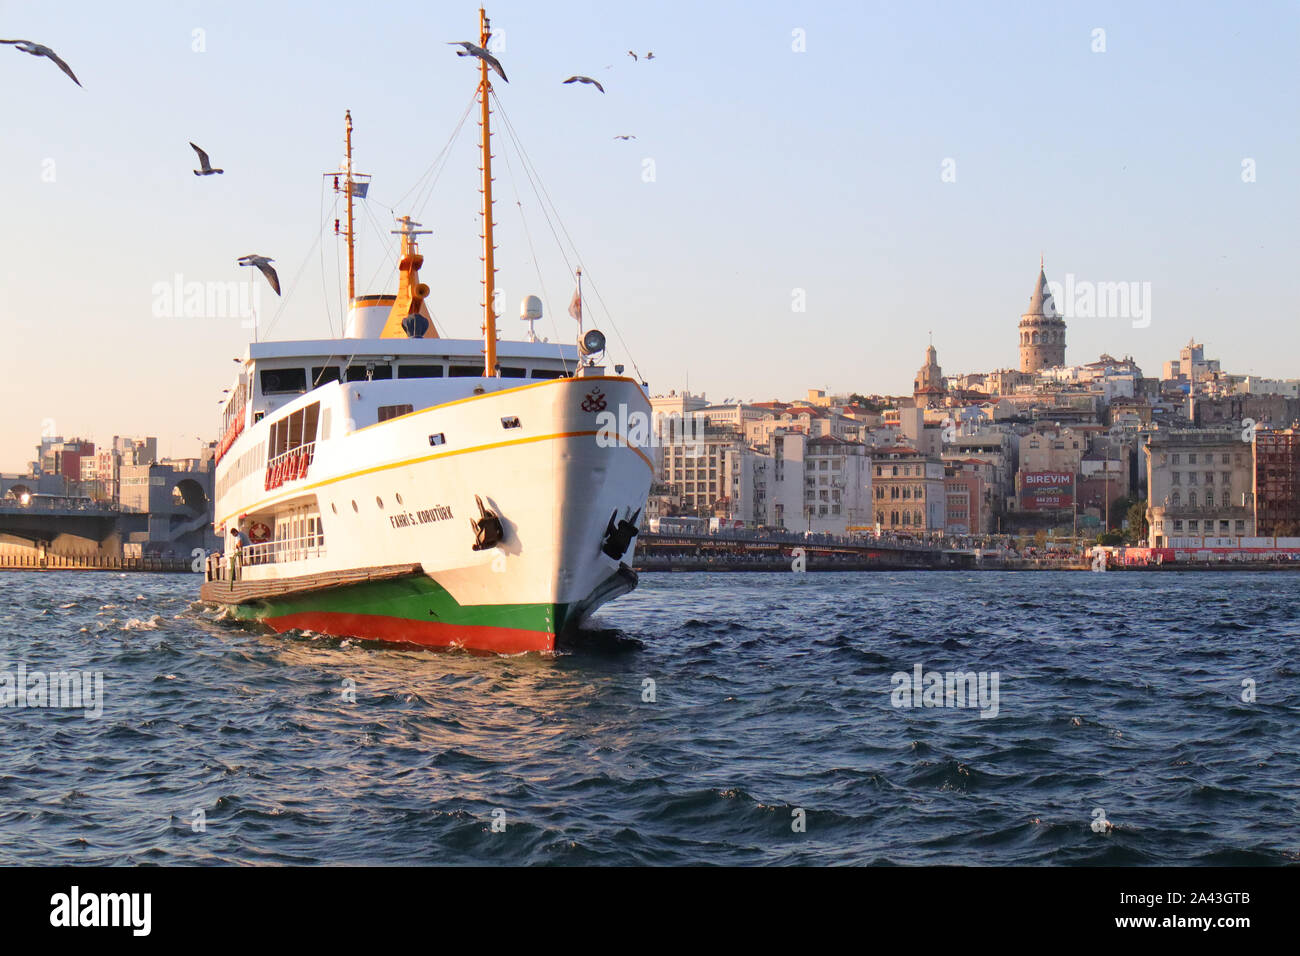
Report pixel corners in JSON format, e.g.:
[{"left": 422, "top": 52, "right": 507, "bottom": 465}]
[{"left": 0, "top": 572, "right": 1300, "bottom": 865}]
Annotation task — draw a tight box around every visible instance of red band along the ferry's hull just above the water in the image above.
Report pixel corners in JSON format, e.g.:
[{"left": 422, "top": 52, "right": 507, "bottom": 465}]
[{"left": 264, "top": 611, "right": 555, "bottom": 654}]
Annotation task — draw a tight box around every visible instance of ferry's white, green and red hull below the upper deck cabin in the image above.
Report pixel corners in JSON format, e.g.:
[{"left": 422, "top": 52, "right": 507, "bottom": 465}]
[{"left": 204, "top": 376, "right": 653, "bottom": 653}]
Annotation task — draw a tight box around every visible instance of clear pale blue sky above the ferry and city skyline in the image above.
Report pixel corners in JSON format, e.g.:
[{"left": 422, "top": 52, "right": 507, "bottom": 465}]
[{"left": 0, "top": 0, "right": 1300, "bottom": 471}]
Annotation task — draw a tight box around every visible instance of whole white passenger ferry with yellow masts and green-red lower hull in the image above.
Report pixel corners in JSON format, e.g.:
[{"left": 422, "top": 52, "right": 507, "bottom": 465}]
[{"left": 202, "top": 10, "right": 654, "bottom": 653}]
